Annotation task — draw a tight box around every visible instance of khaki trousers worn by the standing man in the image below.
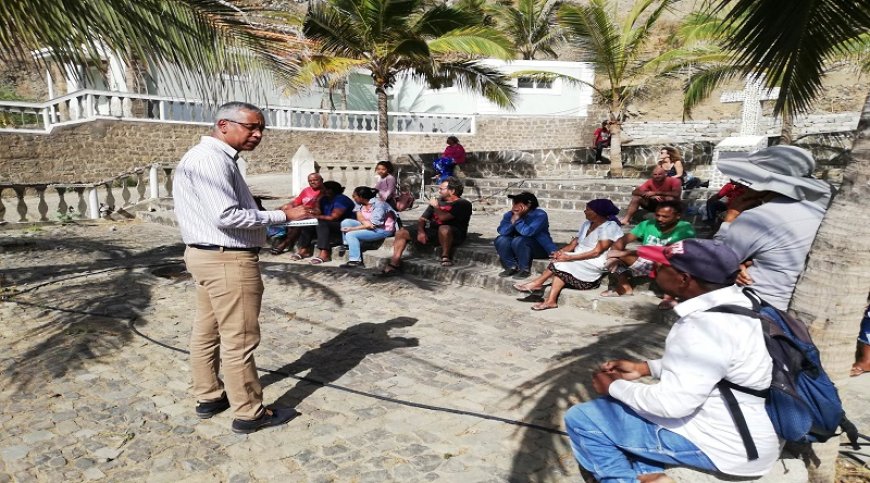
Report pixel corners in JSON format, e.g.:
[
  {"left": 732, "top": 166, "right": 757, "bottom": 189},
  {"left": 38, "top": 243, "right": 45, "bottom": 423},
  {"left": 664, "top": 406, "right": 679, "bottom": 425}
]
[{"left": 184, "top": 247, "right": 264, "bottom": 420}]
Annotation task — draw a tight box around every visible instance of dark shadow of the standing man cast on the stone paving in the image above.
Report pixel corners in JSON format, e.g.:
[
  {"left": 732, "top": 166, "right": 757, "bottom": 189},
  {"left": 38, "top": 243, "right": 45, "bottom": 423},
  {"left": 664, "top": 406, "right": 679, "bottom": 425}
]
[{"left": 260, "top": 317, "right": 419, "bottom": 407}]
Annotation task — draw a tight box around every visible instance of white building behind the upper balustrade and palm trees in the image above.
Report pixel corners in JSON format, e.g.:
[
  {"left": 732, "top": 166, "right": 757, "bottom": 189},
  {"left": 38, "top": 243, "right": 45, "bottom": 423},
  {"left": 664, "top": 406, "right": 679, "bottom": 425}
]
[{"left": 40, "top": 52, "right": 594, "bottom": 117}]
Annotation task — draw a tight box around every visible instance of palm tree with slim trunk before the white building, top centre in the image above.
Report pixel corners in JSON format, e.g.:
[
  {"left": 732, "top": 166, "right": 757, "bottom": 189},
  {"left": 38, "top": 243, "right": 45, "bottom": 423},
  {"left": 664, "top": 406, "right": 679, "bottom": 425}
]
[{"left": 299, "top": 0, "right": 515, "bottom": 159}]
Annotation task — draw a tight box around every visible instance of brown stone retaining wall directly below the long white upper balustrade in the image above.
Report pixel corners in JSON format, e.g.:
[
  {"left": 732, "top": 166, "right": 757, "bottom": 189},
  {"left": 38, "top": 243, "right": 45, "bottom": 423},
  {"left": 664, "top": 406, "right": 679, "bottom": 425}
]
[{"left": 0, "top": 116, "right": 591, "bottom": 183}]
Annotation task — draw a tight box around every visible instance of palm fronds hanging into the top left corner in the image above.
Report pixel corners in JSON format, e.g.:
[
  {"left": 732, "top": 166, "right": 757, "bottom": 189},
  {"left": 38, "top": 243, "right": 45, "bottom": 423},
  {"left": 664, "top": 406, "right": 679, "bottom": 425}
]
[{"left": 0, "top": 0, "right": 299, "bottom": 98}]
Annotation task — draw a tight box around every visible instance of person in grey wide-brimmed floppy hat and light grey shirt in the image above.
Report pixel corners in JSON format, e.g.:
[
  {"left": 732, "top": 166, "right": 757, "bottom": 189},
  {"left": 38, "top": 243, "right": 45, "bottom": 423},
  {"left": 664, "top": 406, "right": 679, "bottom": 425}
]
[{"left": 715, "top": 146, "right": 832, "bottom": 310}]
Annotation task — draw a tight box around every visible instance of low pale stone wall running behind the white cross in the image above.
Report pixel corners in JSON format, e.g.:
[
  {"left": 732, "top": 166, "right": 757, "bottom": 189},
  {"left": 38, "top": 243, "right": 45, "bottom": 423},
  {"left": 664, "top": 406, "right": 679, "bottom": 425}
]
[{"left": 623, "top": 112, "right": 861, "bottom": 143}]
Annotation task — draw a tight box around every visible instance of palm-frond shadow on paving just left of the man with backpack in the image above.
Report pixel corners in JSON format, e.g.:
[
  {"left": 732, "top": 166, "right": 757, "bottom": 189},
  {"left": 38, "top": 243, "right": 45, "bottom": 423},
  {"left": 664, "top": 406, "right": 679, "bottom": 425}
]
[{"left": 500, "top": 323, "right": 670, "bottom": 482}]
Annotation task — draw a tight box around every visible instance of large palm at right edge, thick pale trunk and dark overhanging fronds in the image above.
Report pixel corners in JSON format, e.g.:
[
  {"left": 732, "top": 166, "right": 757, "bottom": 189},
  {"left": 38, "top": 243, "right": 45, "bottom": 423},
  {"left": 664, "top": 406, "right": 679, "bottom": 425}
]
[{"left": 715, "top": 0, "right": 870, "bottom": 482}]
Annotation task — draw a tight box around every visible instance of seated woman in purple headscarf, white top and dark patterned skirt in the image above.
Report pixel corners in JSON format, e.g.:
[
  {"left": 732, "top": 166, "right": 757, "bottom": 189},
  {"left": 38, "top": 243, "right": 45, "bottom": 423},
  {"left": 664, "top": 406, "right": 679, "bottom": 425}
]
[{"left": 514, "top": 199, "right": 623, "bottom": 310}]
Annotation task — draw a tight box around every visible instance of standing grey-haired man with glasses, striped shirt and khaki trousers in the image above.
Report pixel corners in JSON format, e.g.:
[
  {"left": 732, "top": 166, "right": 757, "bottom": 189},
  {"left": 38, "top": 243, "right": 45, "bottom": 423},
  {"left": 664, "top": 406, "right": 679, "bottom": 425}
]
[{"left": 173, "top": 102, "right": 298, "bottom": 433}]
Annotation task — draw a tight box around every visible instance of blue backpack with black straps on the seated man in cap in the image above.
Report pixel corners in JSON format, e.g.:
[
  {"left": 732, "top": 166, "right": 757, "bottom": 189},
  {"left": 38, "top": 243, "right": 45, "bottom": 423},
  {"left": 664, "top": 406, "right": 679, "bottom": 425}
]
[{"left": 708, "top": 289, "right": 858, "bottom": 461}]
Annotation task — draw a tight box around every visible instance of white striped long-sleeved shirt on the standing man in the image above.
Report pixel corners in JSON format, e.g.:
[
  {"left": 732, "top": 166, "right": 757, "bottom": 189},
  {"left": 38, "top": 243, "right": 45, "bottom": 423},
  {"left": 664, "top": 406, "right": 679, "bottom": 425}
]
[{"left": 172, "top": 136, "right": 287, "bottom": 248}]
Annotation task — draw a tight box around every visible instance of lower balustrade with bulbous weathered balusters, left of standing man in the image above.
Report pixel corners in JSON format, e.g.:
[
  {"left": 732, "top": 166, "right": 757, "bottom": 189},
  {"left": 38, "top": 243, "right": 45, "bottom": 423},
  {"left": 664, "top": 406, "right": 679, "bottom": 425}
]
[{"left": 0, "top": 164, "right": 175, "bottom": 223}]
